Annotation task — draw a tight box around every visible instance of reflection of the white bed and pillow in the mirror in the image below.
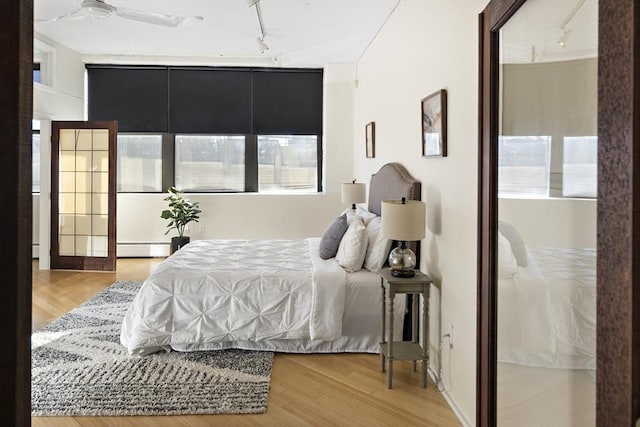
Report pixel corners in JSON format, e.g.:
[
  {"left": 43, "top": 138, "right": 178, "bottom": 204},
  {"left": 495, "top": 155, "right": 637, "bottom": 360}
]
[{"left": 498, "top": 222, "right": 596, "bottom": 370}]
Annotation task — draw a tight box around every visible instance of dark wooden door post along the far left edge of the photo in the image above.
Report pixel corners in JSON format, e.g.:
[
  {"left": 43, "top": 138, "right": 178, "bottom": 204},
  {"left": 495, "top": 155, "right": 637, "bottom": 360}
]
[{"left": 0, "top": 0, "right": 33, "bottom": 426}]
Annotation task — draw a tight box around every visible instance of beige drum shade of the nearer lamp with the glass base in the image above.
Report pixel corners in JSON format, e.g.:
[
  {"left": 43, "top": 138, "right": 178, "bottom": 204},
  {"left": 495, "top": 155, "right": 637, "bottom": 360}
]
[{"left": 381, "top": 200, "right": 427, "bottom": 241}]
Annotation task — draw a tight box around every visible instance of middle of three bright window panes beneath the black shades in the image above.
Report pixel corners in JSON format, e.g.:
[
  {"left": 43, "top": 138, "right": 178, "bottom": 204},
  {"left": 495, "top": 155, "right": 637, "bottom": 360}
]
[{"left": 175, "top": 135, "right": 245, "bottom": 191}]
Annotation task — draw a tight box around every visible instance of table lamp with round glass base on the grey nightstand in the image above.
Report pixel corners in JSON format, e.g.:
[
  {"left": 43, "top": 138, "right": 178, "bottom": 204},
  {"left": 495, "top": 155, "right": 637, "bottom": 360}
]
[{"left": 381, "top": 197, "right": 426, "bottom": 277}]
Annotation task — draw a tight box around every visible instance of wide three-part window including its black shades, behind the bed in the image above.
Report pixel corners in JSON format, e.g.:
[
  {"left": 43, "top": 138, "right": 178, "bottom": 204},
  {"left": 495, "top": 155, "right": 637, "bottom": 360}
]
[{"left": 86, "top": 64, "right": 324, "bottom": 193}]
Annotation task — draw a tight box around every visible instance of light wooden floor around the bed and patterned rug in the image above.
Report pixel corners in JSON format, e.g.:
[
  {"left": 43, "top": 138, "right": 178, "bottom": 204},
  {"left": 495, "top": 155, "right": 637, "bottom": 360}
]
[{"left": 31, "top": 259, "right": 460, "bottom": 427}]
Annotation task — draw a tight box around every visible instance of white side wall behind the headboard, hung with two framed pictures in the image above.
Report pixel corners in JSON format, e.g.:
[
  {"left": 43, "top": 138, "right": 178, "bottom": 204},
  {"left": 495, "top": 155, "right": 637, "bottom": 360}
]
[{"left": 354, "top": 0, "right": 488, "bottom": 424}]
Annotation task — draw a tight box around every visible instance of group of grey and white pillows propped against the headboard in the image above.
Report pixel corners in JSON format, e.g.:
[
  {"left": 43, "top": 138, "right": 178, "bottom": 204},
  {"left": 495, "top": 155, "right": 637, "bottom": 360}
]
[{"left": 319, "top": 208, "right": 391, "bottom": 273}]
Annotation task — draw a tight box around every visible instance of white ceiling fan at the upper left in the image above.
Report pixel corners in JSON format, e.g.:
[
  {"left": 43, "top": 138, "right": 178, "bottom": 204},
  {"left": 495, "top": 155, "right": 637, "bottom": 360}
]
[{"left": 46, "top": 0, "right": 204, "bottom": 27}]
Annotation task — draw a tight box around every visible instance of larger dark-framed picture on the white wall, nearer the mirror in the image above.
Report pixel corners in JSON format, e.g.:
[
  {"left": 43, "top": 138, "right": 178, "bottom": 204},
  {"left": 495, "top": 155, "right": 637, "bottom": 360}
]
[{"left": 421, "top": 89, "right": 447, "bottom": 157}]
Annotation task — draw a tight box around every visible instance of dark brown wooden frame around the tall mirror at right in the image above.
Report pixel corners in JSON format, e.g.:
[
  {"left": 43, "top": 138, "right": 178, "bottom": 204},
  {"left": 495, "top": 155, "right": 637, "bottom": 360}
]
[{"left": 476, "top": 0, "right": 640, "bottom": 426}]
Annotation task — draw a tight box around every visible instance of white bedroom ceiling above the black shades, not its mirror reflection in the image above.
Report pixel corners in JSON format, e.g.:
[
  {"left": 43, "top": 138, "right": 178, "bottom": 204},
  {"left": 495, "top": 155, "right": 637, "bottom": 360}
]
[{"left": 34, "top": 0, "right": 399, "bottom": 67}]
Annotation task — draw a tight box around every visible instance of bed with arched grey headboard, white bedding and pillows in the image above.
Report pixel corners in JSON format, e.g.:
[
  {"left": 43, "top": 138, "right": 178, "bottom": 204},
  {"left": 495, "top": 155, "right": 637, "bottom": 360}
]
[{"left": 120, "top": 163, "right": 421, "bottom": 355}]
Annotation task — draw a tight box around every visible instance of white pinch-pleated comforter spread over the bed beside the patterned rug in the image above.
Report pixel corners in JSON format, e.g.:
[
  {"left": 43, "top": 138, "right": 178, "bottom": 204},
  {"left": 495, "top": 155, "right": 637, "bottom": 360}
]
[{"left": 120, "top": 240, "right": 346, "bottom": 355}]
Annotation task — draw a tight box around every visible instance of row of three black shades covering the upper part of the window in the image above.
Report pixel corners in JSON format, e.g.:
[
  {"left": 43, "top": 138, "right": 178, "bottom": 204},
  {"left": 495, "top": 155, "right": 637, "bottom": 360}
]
[{"left": 87, "top": 65, "right": 323, "bottom": 134}]
